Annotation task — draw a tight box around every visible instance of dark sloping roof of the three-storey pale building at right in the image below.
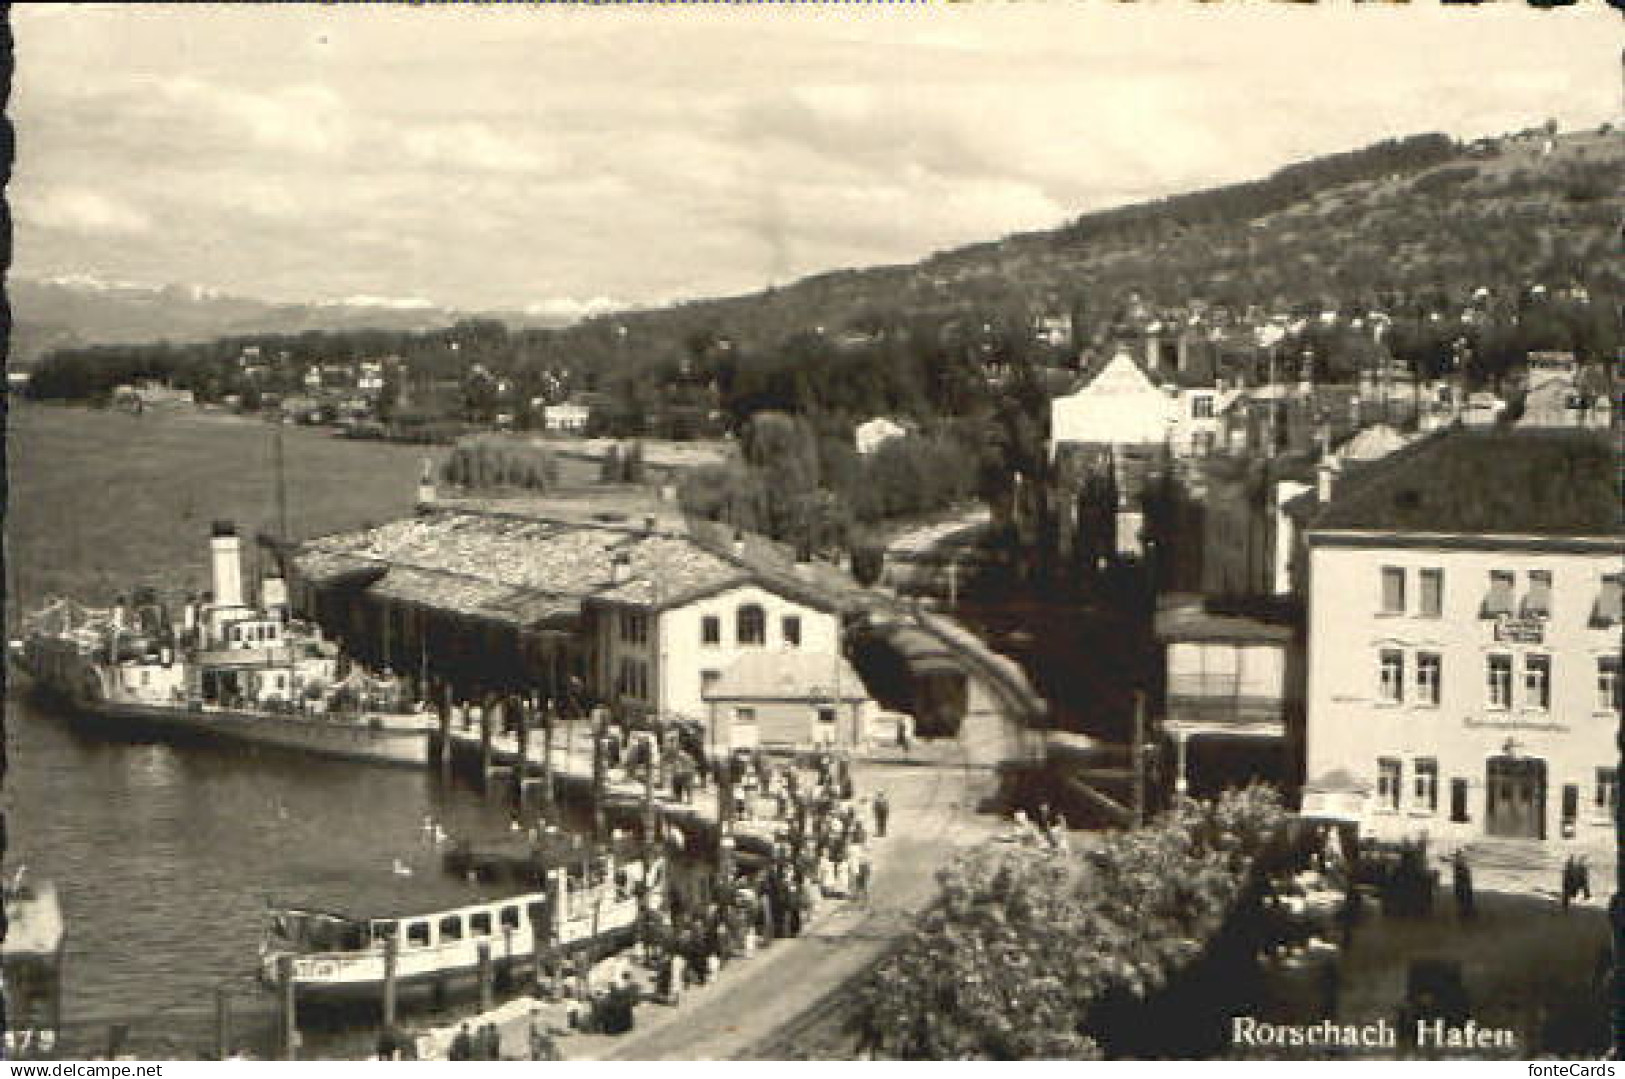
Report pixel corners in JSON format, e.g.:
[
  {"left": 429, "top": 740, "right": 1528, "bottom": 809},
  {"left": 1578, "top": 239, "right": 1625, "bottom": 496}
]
[{"left": 1313, "top": 429, "right": 1620, "bottom": 536}]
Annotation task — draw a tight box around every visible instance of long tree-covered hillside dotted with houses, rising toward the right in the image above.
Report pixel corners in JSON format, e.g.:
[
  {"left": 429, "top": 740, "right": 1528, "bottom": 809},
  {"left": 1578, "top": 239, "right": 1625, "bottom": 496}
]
[{"left": 33, "top": 121, "right": 1625, "bottom": 437}]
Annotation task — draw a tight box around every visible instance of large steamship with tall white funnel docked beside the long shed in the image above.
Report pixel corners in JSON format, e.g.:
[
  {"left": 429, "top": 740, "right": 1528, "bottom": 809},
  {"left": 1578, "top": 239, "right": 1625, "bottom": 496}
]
[{"left": 10, "top": 522, "right": 436, "bottom": 765}]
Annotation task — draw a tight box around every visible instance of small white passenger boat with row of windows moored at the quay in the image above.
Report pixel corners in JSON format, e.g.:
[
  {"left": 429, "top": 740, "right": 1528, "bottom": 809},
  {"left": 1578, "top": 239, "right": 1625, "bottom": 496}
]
[{"left": 260, "top": 852, "right": 666, "bottom": 1001}]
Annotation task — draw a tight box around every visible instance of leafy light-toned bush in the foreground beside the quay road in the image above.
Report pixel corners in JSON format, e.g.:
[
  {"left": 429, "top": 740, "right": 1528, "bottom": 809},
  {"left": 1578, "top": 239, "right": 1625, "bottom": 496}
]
[{"left": 856, "top": 787, "right": 1284, "bottom": 1060}]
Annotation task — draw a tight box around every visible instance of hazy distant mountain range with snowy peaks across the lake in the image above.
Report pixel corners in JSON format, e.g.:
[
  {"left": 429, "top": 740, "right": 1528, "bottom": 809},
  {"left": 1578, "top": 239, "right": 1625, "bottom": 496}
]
[{"left": 7, "top": 275, "right": 572, "bottom": 367}]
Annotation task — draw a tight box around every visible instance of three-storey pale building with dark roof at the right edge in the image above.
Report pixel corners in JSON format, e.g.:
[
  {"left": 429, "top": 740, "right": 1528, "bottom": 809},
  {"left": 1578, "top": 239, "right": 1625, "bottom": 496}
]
[{"left": 1303, "top": 429, "right": 1625, "bottom": 866}]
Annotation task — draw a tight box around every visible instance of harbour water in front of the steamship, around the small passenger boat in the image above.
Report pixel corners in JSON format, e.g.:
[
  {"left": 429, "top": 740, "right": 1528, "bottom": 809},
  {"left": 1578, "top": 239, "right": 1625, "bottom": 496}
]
[{"left": 3, "top": 687, "right": 533, "bottom": 1056}]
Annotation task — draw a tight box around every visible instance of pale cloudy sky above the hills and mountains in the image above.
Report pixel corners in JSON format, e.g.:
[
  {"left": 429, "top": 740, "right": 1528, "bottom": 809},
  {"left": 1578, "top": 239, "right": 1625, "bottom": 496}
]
[{"left": 10, "top": 0, "right": 1622, "bottom": 314}]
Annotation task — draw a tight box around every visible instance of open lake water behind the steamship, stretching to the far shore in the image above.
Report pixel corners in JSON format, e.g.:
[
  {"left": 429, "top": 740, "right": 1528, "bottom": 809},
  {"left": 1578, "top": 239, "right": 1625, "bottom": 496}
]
[{"left": 5, "top": 405, "right": 445, "bottom": 626}]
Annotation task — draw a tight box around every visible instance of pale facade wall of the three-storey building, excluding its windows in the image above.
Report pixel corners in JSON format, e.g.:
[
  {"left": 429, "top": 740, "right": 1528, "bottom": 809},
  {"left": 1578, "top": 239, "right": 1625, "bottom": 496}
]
[{"left": 1307, "top": 543, "right": 1620, "bottom": 845}]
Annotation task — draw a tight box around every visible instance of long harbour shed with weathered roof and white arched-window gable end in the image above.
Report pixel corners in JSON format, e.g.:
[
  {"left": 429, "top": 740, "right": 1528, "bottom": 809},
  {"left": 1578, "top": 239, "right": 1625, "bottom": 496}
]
[{"left": 293, "top": 494, "right": 868, "bottom": 744}]
